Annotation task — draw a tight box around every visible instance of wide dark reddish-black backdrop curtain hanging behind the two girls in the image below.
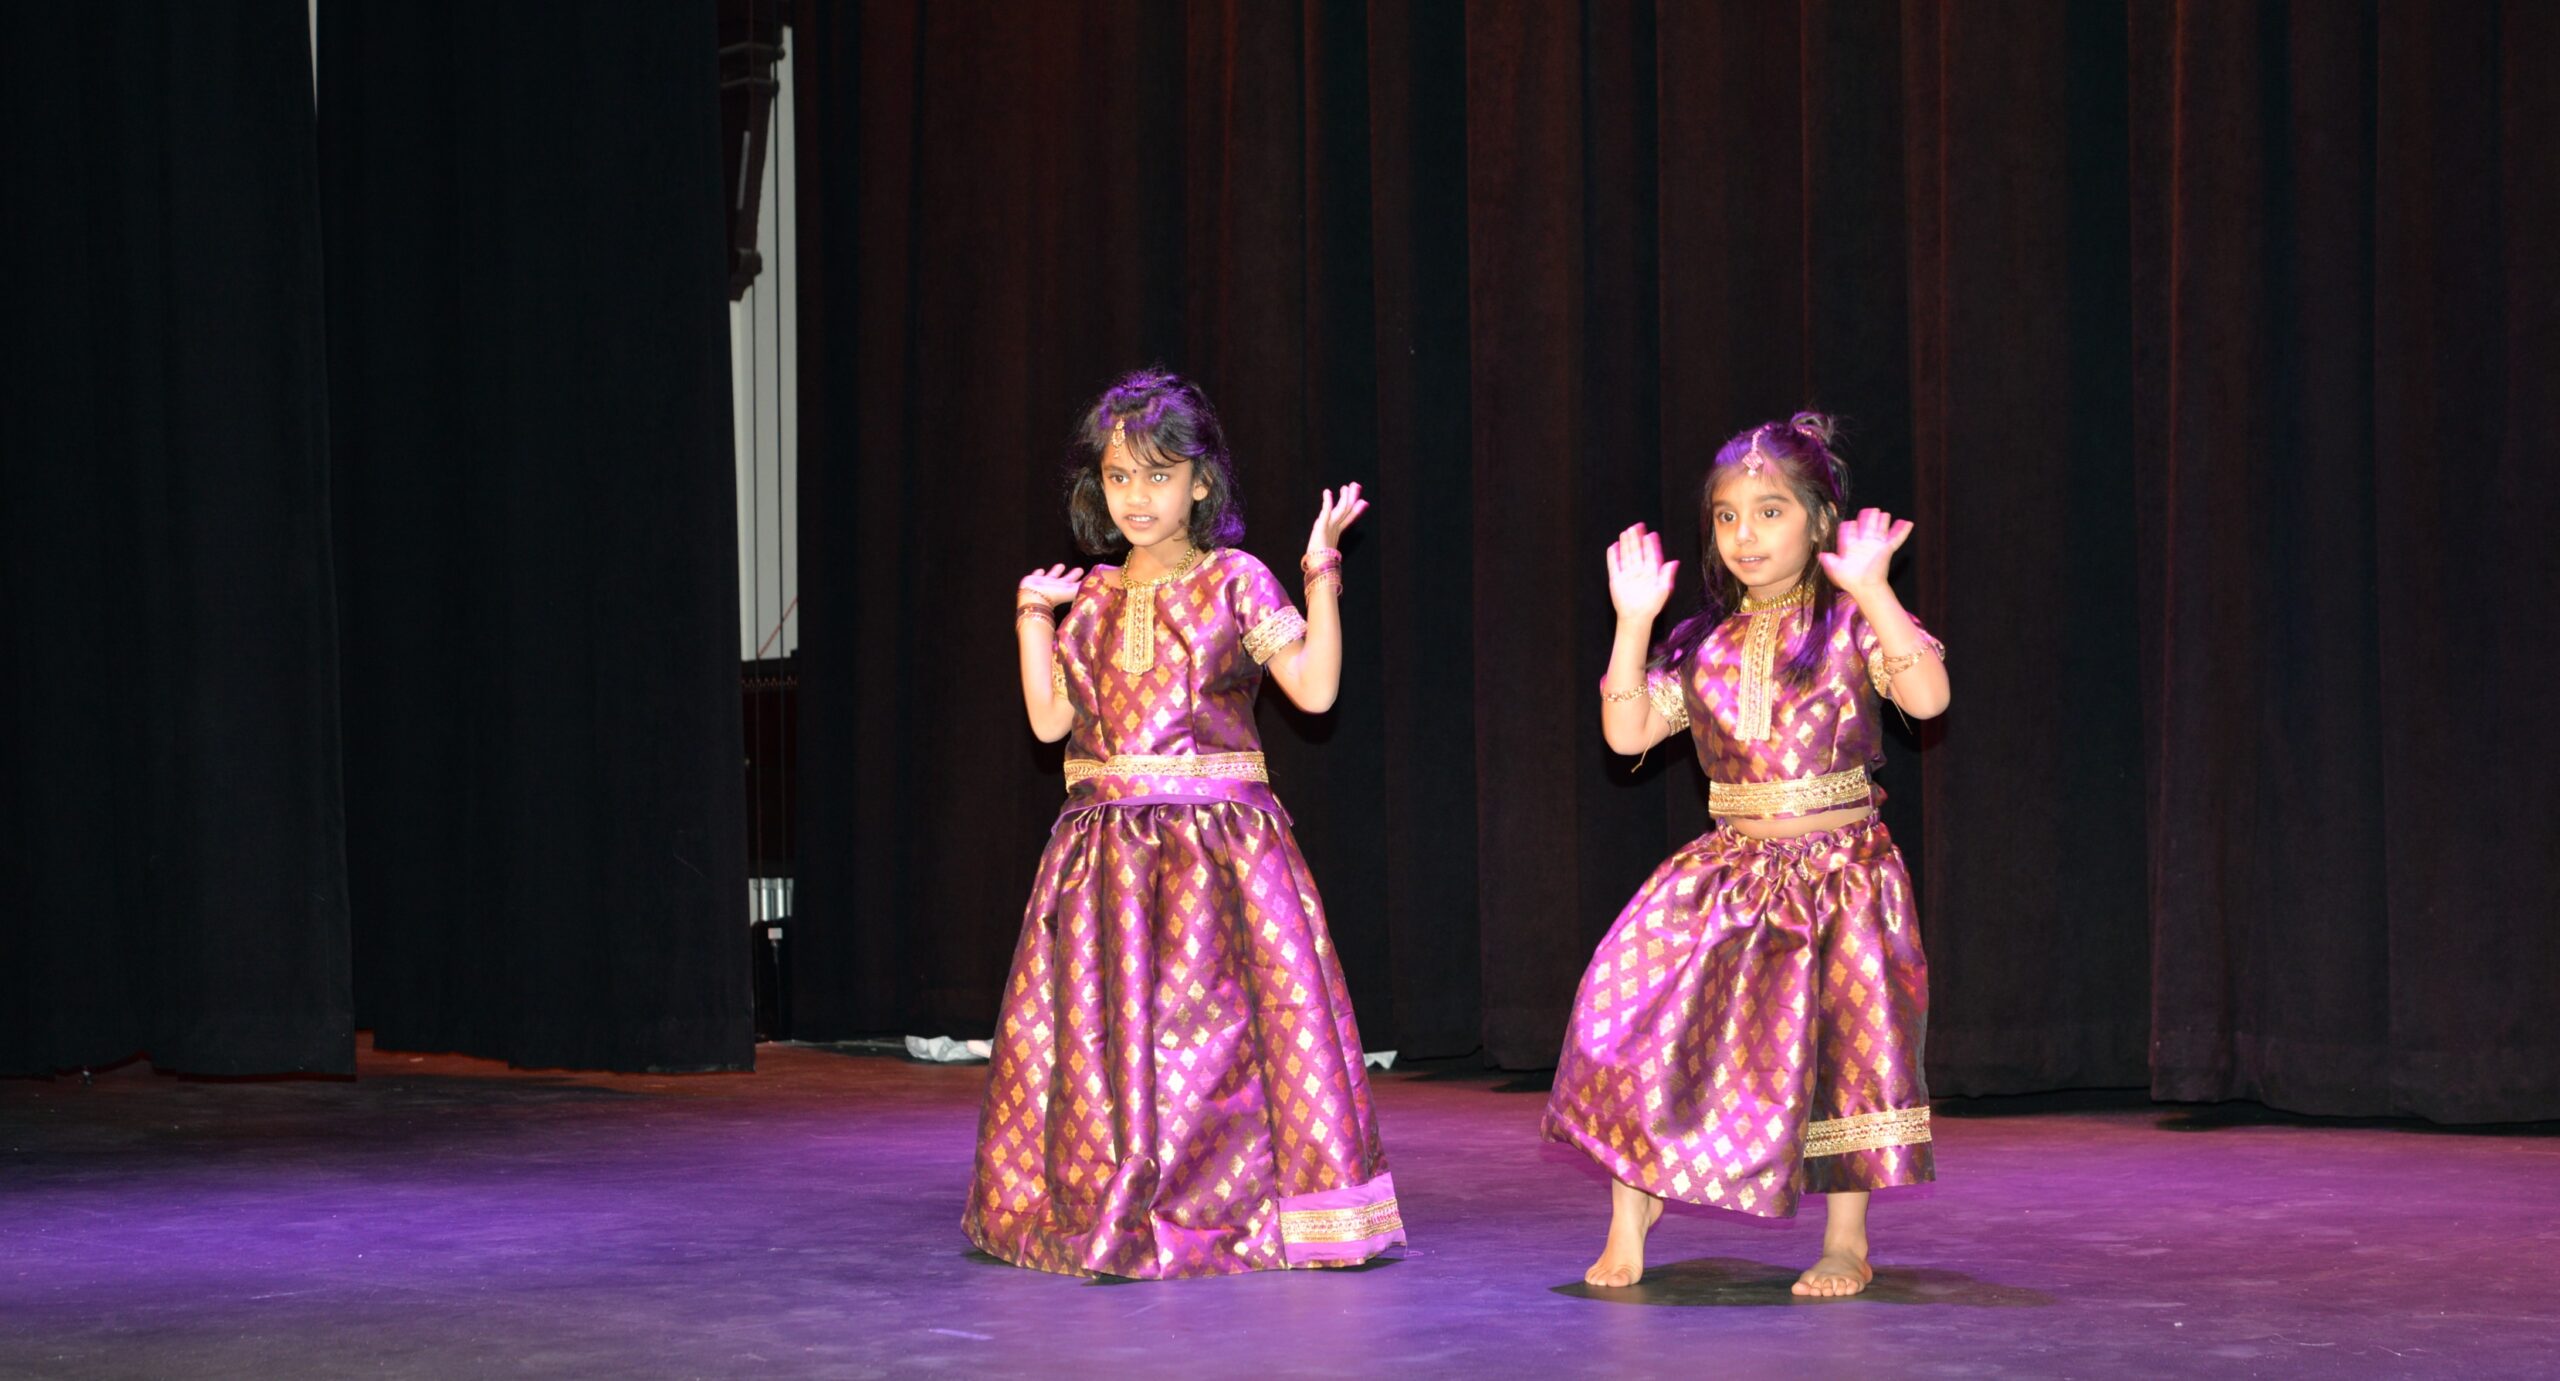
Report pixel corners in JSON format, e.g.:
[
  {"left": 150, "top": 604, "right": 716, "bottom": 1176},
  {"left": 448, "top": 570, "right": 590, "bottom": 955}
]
[{"left": 794, "top": 0, "right": 2560, "bottom": 1120}]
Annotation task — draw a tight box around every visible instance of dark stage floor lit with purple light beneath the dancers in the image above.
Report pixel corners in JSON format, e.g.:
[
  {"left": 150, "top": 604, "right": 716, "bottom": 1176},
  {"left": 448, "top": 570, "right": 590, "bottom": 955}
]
[{"left": 0, "top": 1045, "right": 2560, "bottom": 1381}]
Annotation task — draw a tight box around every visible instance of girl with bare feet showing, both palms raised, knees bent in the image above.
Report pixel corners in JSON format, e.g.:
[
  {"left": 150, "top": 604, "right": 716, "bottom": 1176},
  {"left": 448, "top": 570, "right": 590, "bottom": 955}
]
[{"left": 1544, "top": 413, "right": 1948, "bottom": 1296}]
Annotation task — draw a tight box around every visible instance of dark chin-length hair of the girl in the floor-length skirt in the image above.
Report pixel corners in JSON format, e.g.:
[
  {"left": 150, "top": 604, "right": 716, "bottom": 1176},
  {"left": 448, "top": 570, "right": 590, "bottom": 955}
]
[{"left": 1068, "top": 369, "right": 1244, "bottom": 556}]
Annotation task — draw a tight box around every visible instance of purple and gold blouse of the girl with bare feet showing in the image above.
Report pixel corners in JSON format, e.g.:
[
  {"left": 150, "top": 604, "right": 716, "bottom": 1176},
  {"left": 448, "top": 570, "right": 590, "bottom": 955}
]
[{"left": 1646, "top": 584, "right": 1946, "bottom": 820}]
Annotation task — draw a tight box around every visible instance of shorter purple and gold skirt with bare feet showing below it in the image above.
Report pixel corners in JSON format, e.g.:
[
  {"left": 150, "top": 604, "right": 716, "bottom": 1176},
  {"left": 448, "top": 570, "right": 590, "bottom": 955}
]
[{"left": 1544, "top": 820, "right": 1935, "bottom": 1217}]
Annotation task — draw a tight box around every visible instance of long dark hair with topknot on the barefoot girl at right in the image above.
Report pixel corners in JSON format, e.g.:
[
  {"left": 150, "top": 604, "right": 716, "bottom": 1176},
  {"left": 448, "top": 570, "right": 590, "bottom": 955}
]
[{"left": 1646, "top": 413, "right": 1848, "bottom": 689}]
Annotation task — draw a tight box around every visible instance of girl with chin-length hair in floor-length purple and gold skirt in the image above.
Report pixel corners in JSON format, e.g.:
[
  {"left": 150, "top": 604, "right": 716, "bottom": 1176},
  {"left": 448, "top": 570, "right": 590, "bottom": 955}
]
[{"left": 963, "top": 372, "right": 1405, "bottom": 1279}]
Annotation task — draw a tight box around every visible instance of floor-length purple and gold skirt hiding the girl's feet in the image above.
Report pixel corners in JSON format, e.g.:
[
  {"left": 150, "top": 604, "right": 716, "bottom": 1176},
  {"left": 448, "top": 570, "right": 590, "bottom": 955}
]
[{"left": 963, "top": 802, "right": 1405, "bottom": 1279}]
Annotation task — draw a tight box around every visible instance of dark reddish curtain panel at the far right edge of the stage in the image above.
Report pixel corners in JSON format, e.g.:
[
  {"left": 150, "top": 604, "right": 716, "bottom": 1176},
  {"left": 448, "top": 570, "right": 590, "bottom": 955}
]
[{"left": 2130, "top": 3, "right": 2560, "bottom": 1122}]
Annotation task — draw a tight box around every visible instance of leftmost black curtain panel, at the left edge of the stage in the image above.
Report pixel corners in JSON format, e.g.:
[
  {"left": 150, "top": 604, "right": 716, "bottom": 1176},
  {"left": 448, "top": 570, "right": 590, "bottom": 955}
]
[{"left": 0, "top": 0, "right": 356, "bottom": 1074}]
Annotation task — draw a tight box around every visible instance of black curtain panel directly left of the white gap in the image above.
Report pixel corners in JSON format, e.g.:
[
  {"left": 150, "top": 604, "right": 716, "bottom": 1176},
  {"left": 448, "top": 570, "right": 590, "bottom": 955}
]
[{"left": 320, "top": 0, "right": 753, "bottom": 1068}]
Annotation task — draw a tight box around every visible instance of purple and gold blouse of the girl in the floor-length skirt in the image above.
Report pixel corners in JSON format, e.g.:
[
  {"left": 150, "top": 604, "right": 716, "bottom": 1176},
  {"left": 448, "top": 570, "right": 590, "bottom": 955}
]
[{"left": 1050, "top": 548, "right": 1306, "bottom": 820}]
